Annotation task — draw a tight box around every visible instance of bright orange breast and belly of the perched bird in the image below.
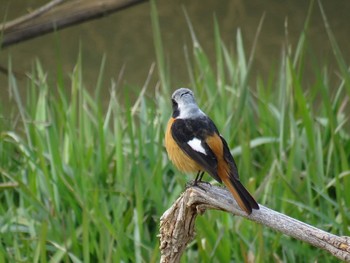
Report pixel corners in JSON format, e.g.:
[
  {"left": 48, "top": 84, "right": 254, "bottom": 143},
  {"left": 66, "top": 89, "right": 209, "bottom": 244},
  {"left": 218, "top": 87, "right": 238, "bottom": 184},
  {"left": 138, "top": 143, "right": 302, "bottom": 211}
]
[{"left": 165, "top": 118, "right": 203, "bottom": 173}]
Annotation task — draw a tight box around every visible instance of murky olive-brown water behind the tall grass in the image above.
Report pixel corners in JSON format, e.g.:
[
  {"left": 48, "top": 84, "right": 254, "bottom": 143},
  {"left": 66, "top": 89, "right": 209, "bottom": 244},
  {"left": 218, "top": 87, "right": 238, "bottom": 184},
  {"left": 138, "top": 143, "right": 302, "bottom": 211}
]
[{"left": 0, "top": 0, "right": 350, "bottom": 105}]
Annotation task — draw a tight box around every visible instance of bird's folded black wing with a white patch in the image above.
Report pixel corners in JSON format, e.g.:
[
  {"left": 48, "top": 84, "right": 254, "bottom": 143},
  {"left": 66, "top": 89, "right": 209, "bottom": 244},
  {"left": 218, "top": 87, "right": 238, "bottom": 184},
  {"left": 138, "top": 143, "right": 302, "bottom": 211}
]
[{"left": 171, "top": 117, "right": 221, "bottom": 183}]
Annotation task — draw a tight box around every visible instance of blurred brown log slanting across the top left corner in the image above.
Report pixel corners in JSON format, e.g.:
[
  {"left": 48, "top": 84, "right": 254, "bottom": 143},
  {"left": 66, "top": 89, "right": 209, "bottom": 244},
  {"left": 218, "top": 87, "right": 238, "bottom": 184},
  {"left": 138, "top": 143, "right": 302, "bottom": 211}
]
[{"left": 0, "top": 0, "right": 147, "bottom": 48}]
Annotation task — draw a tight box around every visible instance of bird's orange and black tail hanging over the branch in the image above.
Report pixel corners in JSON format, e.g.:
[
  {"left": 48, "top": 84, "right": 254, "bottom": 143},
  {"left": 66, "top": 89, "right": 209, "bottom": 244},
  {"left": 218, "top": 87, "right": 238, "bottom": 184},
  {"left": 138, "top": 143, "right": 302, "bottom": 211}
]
[{"left": 221, "top": 176, "right": 259, "bottom": 214}]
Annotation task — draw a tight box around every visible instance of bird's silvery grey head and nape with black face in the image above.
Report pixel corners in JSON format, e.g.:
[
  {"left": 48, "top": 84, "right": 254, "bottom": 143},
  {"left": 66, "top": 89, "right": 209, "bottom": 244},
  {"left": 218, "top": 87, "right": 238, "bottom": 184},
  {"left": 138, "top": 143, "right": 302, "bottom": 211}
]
[{"left": 171, "top": 88, "right": 204, "bottom": 119}]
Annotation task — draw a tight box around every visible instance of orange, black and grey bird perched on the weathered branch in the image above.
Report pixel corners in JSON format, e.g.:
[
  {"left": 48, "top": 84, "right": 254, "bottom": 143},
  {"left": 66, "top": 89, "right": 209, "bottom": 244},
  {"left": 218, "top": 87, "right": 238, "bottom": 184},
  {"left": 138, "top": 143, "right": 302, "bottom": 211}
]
[{"left": 165, "top": 88, "right": 259, "bottom": 215}]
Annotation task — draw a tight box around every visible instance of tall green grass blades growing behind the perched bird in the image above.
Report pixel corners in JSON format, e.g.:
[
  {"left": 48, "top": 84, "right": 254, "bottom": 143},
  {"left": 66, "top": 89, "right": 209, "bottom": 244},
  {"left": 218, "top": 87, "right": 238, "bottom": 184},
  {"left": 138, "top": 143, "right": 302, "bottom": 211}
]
[{"left": 0, "top": 3, "right": 350, "bottom": 262}]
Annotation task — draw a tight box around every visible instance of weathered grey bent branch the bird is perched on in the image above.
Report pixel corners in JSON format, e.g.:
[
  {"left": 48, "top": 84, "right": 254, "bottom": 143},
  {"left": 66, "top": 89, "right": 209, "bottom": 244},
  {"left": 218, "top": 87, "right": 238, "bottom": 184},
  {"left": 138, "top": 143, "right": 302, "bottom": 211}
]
[{"left": 159, "top": 183, "right": 350, "bottom": 262}]
